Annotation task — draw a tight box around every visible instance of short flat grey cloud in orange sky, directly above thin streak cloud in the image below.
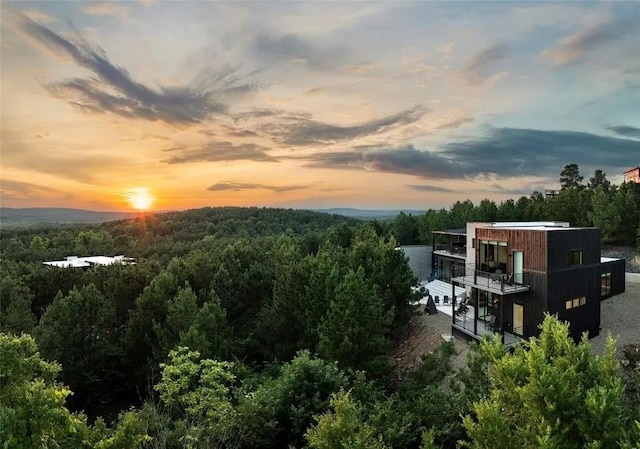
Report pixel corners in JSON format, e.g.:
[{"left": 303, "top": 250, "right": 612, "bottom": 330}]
[{"left": 162, "top": 142, "right": 278, "bottom": 164}]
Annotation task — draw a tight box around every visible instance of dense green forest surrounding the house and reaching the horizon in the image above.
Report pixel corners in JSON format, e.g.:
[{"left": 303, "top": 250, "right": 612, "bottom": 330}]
[{"left": 0, "top": 167, "right": 640, "bottom": 449}]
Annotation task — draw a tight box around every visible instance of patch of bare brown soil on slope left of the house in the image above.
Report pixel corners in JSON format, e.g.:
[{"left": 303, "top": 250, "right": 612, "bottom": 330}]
[{"left": 392, "top": 306, "right": 468, "bottom": 378}]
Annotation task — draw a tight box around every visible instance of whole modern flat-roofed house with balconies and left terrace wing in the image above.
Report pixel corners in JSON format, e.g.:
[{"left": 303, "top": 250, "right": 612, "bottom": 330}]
[{"left": 433, "top": 222, "right": 625, "bottom": 344}]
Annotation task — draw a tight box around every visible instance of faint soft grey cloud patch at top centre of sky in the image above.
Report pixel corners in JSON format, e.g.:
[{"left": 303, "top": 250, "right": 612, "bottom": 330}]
[{"left": 253, "top": 34, "right": 353, "bottom": 70}]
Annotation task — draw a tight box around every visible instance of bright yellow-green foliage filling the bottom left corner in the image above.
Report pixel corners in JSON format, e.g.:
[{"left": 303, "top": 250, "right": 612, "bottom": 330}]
[{"left": 0, "top": 333, "right": 148, "bottom": 449}]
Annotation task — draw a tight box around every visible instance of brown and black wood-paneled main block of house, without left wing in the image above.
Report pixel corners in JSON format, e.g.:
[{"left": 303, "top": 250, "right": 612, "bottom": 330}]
[{"left": 452, "top": 223, "right": 624, "bottom": 340}]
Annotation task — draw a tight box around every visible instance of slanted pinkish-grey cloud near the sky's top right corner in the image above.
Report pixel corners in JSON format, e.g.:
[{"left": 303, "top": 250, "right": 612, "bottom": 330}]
[{"left": 540, "top": 16, "right": 640, "bottom": 65}]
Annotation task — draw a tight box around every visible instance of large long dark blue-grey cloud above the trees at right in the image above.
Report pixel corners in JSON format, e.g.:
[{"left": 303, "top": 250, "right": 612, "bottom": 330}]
[{"left": 303, "top": 128, "right": 640, "bottom": 179}]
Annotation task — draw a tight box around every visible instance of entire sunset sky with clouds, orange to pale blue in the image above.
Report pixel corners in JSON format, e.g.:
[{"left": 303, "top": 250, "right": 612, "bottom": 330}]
[{"left": 0, "top": 0, "right": 640, "bottom": 210}]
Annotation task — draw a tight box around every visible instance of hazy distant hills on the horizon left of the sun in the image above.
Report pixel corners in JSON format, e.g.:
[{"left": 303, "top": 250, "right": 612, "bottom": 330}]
[{"left": 0, "top": 207, "right": 136, "bottom": 228}]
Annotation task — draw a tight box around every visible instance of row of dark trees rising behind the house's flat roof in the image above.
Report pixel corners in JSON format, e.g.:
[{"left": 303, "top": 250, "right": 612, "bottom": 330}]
[{"left": 393, "top": 164, "right": 640, "bottom": 249}]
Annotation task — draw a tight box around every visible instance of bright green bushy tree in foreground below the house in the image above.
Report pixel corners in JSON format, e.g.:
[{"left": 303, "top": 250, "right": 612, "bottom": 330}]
[{"left": 464, "top": 316, "right": 628, "bottom": 449}]
